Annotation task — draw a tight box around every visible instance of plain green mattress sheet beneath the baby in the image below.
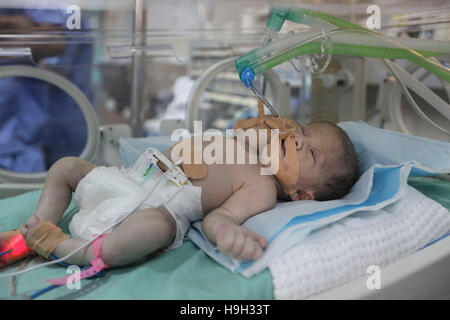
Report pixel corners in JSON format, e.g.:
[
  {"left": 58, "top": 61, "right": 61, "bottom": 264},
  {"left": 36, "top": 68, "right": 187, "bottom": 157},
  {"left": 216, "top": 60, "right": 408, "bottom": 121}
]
[{"left": 0, "top": 177, "right": 450, "bottom": 300}]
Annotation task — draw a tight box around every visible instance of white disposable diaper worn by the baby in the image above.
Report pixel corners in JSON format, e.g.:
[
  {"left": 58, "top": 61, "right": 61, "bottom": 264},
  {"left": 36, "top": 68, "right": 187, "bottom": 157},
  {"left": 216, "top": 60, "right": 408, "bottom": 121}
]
[{"left": 69, "top": 148, "right": 203, "bottom": 249}]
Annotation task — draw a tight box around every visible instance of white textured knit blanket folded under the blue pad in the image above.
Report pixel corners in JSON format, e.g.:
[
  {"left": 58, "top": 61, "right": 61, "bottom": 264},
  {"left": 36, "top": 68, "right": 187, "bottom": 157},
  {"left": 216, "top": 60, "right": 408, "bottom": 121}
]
[{"left": 269, "top": 186, "right": 450, "bottom": 299}]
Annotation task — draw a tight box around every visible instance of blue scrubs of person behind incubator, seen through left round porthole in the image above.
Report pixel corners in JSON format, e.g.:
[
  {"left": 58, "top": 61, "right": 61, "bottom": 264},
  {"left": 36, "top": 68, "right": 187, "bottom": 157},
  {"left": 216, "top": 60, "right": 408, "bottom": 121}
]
[{"left": 0, "top": 9, "right": 93, "bottom": 172}]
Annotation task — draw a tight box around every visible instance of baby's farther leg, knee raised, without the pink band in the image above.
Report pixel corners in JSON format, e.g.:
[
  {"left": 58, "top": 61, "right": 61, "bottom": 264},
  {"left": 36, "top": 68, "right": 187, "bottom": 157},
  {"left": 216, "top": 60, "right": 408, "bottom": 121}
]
[{"left": 20, "top": 157, "right": 96, "bottom": 238}]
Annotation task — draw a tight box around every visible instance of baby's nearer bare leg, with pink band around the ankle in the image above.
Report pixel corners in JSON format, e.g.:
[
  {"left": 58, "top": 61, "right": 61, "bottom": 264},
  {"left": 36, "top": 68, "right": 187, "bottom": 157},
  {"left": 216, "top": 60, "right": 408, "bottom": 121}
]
[{"left": 54, "top": 207, "right": 176, "bottom": 267}]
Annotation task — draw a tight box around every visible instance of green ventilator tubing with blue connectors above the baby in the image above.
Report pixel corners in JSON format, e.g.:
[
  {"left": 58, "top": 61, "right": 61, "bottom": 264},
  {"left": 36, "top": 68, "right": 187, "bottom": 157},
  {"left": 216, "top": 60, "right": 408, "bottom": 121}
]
[{"left": 235, "top": 9, "right": 450, "bottom": 82}]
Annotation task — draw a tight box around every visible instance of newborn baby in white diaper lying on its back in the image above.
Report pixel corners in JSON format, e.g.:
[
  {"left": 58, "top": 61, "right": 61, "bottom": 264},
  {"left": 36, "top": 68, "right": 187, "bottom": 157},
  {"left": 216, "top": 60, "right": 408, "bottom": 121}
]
[{"left": 0, "top": 116, "right": 358, "bottom": 267}]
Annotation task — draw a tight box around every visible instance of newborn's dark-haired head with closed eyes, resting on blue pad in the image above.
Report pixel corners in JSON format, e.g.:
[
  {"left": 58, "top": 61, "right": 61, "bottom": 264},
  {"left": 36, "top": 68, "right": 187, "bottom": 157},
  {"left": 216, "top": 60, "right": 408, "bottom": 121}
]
[{"left": 281, "top": 121, "right": 359, "bottom": 201}]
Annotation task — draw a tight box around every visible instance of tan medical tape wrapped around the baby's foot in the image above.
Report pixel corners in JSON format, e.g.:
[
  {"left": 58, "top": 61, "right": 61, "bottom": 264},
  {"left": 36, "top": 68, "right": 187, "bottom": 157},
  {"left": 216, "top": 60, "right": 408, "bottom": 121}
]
[{"left": 26, "top": 221, "right": 69, "bottom": 259}]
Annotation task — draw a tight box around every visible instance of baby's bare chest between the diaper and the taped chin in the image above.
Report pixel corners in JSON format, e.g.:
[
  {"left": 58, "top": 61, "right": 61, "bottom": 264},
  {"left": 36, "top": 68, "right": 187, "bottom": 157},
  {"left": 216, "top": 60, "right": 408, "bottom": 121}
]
[{"left": 164, "top": 137, "right": 274, "bottom": 215}]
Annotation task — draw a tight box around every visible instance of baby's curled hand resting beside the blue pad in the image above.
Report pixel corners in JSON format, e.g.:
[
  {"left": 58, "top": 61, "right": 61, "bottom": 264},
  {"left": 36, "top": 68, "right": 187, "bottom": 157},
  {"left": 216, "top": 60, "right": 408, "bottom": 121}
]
[{"left": 216, "top": 224, "right": 267, "bottom": 260}]
